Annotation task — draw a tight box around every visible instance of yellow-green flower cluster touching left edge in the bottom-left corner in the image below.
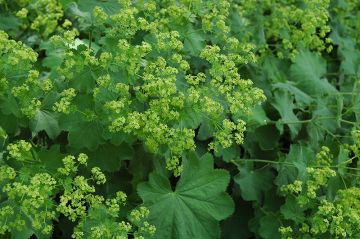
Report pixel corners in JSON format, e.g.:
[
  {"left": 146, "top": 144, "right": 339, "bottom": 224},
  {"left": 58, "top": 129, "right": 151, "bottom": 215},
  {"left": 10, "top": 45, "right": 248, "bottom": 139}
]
[{"left": 0, "top": 170, "right": 56, "bottom": 235}]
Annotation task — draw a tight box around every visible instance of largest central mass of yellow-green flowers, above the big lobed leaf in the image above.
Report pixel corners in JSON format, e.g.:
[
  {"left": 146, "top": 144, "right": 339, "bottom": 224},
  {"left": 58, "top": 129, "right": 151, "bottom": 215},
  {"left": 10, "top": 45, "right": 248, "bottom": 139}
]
[{"left": 28, "top": 0, "right": 265, "bottom": 175}]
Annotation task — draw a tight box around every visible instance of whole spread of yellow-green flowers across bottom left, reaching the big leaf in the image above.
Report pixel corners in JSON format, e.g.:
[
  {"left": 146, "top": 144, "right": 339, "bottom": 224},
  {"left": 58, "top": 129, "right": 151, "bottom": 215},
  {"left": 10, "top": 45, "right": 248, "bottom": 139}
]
[{"left": 0, "top": 145, "right": 155, "bottom": 239}]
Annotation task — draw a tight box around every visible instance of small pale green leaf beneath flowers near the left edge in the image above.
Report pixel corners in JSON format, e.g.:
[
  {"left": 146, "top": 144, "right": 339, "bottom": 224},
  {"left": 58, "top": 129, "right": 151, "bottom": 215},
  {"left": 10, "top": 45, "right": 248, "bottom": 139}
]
[{"left": 30, "top": 110, "right": 61, "bottom": 139}]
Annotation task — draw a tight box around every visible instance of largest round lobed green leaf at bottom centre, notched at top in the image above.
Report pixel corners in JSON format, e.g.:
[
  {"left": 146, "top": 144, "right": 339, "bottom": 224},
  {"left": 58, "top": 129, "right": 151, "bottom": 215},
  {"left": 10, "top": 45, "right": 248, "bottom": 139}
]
[{"left": 138, "top": 154, "right": 234, "bottom": 239}]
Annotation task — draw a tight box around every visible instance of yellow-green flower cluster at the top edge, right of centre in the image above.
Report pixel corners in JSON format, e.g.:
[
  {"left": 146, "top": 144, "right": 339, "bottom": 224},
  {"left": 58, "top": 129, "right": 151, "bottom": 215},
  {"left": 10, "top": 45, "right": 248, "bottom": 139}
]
[{"left": 238, "top": 0, "right": 332, "bottom": 58}]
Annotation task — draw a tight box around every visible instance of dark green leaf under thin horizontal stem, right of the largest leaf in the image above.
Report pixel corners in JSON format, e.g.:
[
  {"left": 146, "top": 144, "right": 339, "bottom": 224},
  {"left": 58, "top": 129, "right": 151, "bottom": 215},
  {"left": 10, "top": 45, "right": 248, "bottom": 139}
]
[{"left": 234, "top": 165, "right": 274, "bottom": 202}]
